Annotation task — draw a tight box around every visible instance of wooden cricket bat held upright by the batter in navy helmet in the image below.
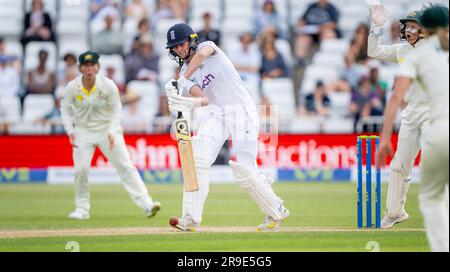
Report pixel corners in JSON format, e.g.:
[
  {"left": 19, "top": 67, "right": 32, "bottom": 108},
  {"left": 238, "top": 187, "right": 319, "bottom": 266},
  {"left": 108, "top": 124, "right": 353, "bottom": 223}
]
[{"left": 173, "top": 81, "right": 199, "bottom": 192}]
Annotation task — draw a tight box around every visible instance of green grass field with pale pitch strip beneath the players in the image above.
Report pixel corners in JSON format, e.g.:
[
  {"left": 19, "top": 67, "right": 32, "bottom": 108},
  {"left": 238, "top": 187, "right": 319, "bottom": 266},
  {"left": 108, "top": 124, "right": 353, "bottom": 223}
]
[{"left": 0, "top": 183, "right": 429, "bottom": 252}]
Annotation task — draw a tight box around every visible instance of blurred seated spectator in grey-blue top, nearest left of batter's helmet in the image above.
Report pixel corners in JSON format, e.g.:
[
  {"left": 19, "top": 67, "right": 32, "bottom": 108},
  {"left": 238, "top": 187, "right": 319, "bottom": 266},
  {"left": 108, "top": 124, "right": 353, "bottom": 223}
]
[{"left": 125, "top": 36, "right": 159, "bottom": 83}]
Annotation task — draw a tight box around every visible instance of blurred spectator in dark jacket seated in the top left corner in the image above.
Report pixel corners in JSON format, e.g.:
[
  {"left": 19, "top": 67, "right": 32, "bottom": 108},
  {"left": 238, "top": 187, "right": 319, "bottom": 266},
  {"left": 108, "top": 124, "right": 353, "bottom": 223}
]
[{"left": 22, "top": 0, "right": 55, "bottom": 48}]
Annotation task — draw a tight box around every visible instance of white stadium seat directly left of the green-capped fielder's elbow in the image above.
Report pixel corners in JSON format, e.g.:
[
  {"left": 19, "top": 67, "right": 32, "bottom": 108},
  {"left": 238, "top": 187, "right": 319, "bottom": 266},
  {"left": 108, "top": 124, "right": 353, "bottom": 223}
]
[{"left": 23, "top": 94, "right": 55, "bottom": 123}]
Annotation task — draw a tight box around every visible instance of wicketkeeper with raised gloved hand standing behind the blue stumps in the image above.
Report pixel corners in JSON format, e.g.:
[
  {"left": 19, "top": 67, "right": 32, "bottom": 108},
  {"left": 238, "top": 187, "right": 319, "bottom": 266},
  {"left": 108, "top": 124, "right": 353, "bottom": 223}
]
[{"left": 367, "top": 5, "right": 430, "bottom": 229}]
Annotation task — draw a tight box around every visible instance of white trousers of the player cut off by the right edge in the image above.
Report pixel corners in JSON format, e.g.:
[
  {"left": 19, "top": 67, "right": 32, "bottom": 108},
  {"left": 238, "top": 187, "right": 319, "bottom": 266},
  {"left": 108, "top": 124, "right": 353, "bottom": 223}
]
[{"left": 419, "top": 119, "right": 449, "bottom": 252}]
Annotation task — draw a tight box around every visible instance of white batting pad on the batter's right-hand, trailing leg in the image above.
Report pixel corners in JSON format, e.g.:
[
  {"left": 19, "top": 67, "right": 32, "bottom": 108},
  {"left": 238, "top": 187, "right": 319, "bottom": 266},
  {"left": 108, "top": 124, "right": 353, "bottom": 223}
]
[{"left": 229, "top": 161, "right": 282, "bottom": 220}]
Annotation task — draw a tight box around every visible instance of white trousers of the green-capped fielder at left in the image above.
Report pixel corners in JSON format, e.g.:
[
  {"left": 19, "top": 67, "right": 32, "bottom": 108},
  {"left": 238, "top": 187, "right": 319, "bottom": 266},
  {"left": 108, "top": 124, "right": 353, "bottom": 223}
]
[{"left": 73, "top": 127, "right": 153, "bottom": 211}]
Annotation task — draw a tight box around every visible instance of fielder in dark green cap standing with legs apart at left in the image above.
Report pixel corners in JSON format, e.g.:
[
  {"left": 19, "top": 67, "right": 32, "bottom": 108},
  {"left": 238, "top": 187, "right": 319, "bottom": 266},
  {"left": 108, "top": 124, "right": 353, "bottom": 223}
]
[{"left": 61, "top": 51, "right": 161, "bottom": 219}]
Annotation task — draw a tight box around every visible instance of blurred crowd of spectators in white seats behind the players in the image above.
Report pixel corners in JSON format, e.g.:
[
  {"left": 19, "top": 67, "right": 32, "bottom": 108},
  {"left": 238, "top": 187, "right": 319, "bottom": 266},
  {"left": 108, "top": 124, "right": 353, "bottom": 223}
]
[{"left": 0, "top": 0, "right": 448, "bottom": 134}]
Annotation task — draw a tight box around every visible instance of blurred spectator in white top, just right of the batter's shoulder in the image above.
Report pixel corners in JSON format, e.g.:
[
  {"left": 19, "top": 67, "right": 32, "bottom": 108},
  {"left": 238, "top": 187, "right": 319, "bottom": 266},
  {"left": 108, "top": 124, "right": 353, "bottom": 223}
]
[{"left": 229, "top": 32, "right": 261, "bottom": 81}]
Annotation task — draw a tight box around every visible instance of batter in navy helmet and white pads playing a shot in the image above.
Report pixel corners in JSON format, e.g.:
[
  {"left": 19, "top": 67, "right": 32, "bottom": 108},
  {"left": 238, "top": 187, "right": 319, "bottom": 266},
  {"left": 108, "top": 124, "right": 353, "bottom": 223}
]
[{"left": 166, "top": 24, "right": 289, "bottom": 231}]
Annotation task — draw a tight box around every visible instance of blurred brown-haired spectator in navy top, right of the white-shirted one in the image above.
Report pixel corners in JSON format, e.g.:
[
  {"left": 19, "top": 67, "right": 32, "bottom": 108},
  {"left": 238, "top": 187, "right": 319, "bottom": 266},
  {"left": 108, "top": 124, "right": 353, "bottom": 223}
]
[{"left": 260, "top": 34, "right": 288, "bottom": 79}]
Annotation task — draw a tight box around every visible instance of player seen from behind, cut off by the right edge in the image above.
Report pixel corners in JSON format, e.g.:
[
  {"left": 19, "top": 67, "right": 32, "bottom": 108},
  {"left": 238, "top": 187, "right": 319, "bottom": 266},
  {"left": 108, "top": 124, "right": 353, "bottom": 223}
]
[{"left": 377, "top": 6, "right": 449, "bottom": 252}]
